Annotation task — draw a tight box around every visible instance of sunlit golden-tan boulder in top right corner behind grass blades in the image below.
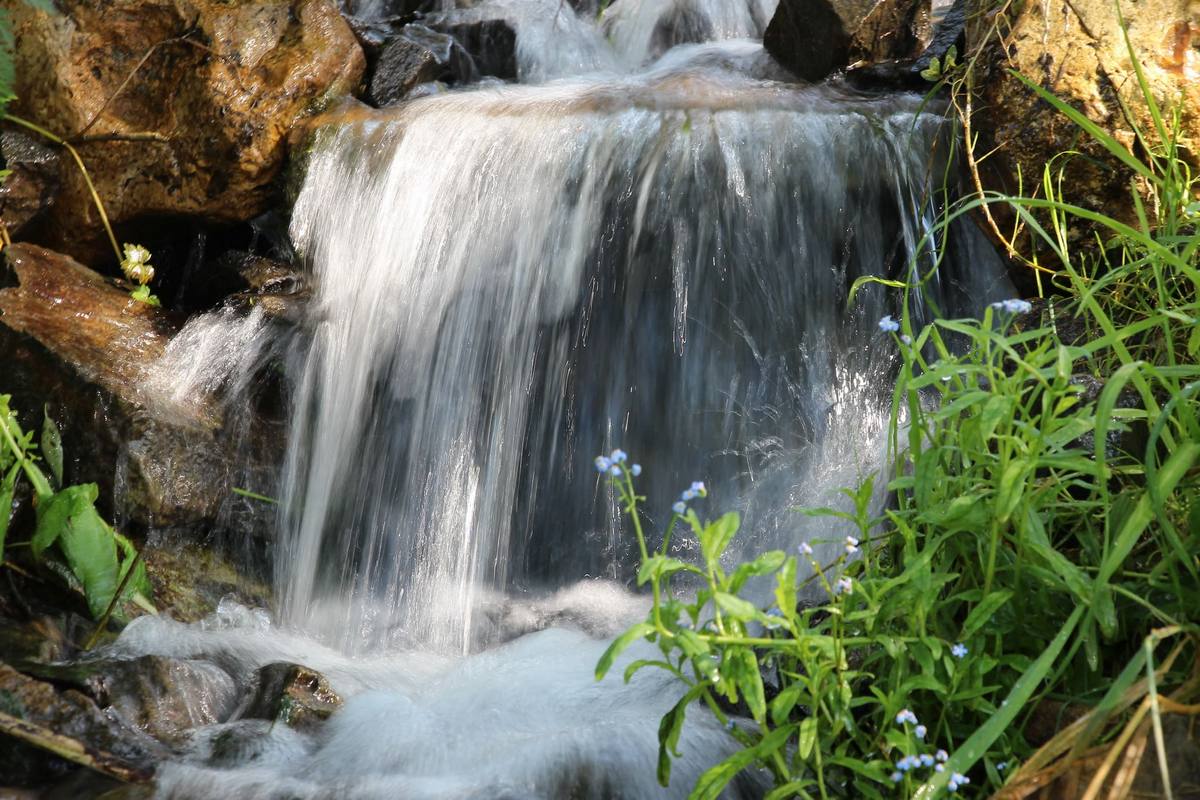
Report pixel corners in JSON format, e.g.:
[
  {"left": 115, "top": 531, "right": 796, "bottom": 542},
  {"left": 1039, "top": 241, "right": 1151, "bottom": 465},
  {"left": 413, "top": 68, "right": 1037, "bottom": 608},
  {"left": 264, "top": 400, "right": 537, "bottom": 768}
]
[{"left": 974, "top": 0, "right": 1200, "bottom": 235}]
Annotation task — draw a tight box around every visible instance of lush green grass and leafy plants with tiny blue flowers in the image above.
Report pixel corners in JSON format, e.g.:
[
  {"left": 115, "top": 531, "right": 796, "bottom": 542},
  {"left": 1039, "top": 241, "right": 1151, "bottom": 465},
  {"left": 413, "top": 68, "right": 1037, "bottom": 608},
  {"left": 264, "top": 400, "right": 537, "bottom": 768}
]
[{"left": 598, "top": 42, "right": 1200, "bottom": 799}]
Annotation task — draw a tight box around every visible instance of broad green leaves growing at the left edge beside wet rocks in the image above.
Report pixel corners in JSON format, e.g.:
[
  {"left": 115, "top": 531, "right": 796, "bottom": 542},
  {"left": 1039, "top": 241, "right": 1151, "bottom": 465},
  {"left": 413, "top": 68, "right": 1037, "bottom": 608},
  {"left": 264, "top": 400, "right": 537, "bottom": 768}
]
[{"left": 0, "top": 395, "right": 154, "bottom": 620}]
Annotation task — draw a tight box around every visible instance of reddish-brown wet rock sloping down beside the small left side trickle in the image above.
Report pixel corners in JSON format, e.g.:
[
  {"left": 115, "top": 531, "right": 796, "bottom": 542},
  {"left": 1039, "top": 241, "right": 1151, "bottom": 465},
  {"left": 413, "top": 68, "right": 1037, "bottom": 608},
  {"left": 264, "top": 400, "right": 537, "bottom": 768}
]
[{"left": 0, "top": 245, "right": 274, "bottom": 527}]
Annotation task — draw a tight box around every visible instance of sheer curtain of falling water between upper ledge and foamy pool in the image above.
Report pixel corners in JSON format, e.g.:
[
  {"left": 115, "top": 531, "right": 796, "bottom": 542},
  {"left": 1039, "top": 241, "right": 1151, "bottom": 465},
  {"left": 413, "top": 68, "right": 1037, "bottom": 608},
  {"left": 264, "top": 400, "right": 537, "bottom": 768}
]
[{"left": 278, "top": 74, "right": 1003, "bottom": 649}]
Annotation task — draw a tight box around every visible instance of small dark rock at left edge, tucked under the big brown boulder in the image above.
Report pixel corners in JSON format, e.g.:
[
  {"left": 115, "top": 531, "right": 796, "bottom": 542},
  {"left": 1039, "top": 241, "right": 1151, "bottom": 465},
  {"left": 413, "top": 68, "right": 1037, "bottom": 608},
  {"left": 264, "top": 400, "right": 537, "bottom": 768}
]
[{"left": 0, "top": 131, "right": 59, "bottom": 237}]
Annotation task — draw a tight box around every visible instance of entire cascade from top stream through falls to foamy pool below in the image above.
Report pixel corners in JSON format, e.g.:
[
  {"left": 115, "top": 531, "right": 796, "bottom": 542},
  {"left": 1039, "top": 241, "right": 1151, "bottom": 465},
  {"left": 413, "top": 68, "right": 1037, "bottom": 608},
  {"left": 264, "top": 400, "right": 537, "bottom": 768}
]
[{"left": 116, "top": 0, "right": 1002, "bottom": 798}]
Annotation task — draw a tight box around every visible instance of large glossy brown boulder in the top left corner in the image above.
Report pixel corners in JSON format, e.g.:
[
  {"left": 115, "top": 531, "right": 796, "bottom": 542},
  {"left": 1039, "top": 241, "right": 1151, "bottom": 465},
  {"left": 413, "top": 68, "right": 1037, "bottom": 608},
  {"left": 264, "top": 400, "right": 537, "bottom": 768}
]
[{"left": 11, "top": 0, "right": 365, "bottom": 262}]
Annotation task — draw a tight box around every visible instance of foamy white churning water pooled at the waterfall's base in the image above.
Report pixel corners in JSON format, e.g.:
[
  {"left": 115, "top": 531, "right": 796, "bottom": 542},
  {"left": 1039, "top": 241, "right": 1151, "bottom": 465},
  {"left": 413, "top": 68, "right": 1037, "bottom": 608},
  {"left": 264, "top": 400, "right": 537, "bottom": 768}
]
[{"left": 119, "top": 597, "right": 762, "bottom": 800}]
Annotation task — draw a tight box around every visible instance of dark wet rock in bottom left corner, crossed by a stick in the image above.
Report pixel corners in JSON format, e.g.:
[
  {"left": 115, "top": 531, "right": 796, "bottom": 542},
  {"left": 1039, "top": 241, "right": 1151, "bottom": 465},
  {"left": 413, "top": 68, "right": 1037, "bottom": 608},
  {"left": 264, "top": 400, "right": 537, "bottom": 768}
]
[{"left": 0, "top": 664, "right": 156, "bottom": 786}]
